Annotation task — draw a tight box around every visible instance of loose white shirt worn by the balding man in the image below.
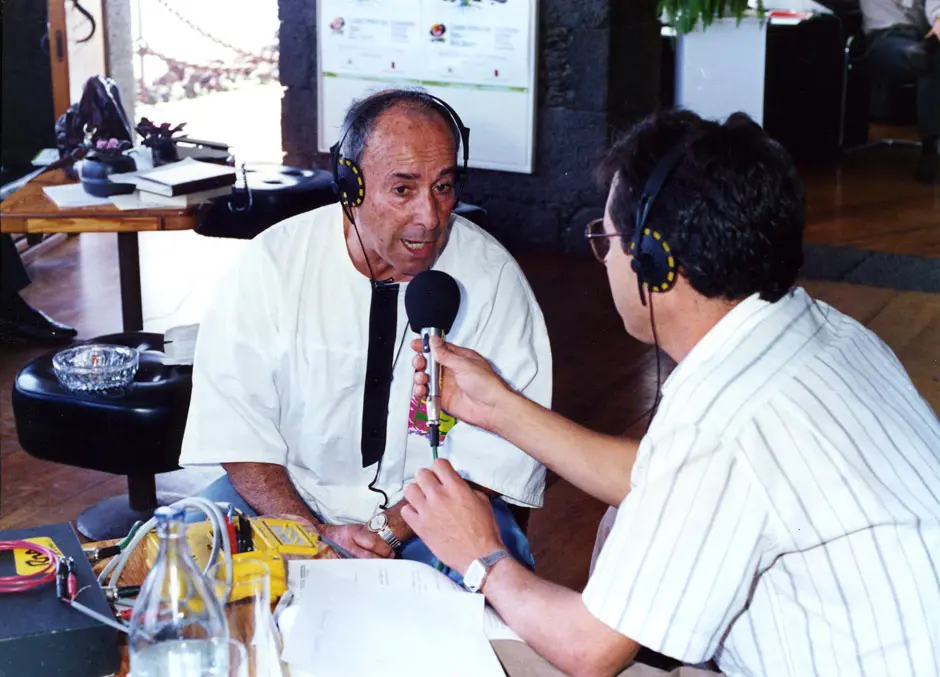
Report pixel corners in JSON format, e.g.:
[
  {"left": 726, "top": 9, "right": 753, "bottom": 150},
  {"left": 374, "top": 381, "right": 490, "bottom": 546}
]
[{"left": 180, "top": 204, "right": 552, "bottom": 523}]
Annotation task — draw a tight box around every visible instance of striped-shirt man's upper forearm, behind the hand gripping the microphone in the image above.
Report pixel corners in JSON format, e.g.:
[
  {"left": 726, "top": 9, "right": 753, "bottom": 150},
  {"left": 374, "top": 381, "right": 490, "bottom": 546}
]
[{"left": 493, "top": 393, "right": 639, "bottom": 506}]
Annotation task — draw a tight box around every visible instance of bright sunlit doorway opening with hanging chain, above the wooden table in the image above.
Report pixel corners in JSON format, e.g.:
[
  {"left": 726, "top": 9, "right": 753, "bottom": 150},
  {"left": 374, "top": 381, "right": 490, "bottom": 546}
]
[{"left": 131, "top": 0, "right": 283, "bottom": 163}]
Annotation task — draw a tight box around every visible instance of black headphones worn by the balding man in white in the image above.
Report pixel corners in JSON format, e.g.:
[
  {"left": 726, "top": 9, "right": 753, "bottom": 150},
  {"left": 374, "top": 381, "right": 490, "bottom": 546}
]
[{"left": 330, "top": 89, "right": 470, "bottom": 208}]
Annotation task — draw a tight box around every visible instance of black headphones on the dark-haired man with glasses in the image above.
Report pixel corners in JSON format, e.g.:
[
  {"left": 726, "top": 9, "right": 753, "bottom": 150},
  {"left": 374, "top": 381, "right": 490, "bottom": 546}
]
[{"left": 629, "top": 143, "right": 685, "bottom": 306}]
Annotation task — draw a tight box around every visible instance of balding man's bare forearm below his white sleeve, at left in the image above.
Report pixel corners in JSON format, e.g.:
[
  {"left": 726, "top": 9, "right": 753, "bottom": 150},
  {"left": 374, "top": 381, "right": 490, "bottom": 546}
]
[{"left": 222, "top": 463, "right": 321, "bottom": 526}]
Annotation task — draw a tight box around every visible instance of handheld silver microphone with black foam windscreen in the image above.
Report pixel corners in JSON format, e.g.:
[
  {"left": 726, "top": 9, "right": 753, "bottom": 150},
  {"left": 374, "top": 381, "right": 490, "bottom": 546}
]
[{"left": 405, "top": 270, "right": 460, "bottom": 458}]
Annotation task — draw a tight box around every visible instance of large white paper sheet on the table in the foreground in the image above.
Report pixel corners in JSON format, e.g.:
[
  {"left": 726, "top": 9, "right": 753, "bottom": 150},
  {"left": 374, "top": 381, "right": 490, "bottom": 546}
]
[{"left": 283, "top": 561, "right": 505, "bottom": 677}]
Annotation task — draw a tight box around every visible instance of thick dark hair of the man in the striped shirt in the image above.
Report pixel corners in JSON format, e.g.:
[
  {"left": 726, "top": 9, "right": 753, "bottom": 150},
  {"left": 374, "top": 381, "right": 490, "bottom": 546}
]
[{"left": 599, "top": 109, "right": 806, "bottom": 302}]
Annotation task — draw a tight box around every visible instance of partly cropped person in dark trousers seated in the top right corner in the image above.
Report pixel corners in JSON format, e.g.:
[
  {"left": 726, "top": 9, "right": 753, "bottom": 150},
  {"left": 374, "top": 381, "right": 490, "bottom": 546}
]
[{"left": 860, "top": 0, "right": 940, "bottom": 183}]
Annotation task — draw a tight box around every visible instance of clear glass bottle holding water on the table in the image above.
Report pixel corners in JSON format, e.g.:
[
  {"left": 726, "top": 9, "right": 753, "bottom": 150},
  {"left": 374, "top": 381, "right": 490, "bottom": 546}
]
[{"left": 128, "top": 507, "right": 228, "bottom": 677}]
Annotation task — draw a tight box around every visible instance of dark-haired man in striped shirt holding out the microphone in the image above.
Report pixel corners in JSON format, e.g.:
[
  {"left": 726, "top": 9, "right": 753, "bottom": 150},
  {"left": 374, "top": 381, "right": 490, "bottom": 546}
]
[{"left": 402, "top": 111, "right": 940, "bottom": 677}]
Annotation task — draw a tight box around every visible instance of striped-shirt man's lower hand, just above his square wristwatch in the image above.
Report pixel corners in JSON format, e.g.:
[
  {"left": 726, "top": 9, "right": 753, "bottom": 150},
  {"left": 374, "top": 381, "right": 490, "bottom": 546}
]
[{"left": 401, "top": 459, "right": 505, "bottom": 575}]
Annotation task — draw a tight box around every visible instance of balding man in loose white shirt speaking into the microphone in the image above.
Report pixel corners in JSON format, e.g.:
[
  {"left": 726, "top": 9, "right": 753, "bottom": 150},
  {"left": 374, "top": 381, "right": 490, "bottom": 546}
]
[{"left": 180, "top": 90, "right": 552, "bottom": 566}]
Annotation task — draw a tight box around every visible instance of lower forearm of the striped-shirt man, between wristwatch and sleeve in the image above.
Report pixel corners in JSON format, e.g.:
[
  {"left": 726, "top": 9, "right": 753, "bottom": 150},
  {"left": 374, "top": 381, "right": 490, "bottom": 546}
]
[{"left": 483, "top": 558, "right": 639, "bottom": 677}]
